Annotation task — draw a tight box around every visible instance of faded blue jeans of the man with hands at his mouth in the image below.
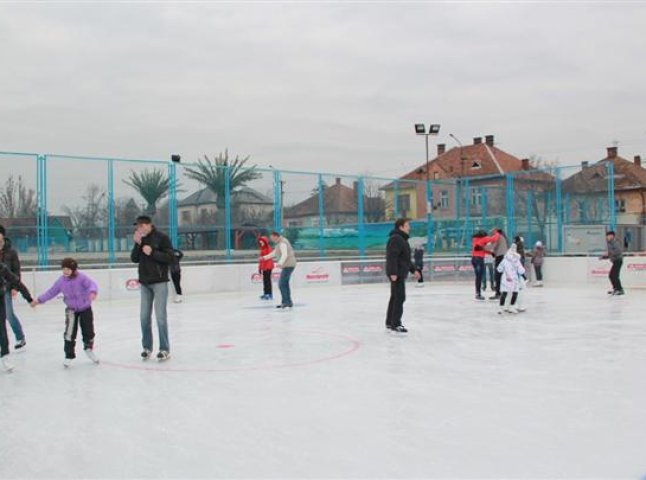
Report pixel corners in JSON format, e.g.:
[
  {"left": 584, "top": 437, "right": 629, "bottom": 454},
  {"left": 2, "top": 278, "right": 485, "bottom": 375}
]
[{"left": 140, "top": 282, "right": 170, "bottom": 352}]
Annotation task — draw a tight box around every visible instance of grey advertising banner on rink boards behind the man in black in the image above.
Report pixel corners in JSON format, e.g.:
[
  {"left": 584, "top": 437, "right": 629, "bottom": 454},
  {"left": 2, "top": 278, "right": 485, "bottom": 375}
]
[{"left": 341, "top": 258, "right": 473, "bottom": 285}]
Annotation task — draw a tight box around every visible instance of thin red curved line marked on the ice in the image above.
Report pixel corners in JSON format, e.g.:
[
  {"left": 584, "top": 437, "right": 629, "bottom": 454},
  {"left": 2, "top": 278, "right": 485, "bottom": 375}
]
[{"left": 101, "top": 331, "right": 361, "bottom": 373}]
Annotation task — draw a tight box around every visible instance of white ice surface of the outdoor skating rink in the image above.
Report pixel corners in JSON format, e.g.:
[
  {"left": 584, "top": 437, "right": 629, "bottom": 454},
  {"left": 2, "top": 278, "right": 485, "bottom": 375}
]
[{"left": 0, "top": 283, "right": 646, "bottom": 479}]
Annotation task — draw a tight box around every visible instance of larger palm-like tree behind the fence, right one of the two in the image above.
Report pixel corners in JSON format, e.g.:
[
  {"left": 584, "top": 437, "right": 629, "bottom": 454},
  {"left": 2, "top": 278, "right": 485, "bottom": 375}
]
[{"left": 184, "top": 150, "right": 262, "bottom": 247}]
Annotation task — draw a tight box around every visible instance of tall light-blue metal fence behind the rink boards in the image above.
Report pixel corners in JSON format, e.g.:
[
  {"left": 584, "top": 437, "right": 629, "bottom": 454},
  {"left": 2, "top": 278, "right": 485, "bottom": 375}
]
[{"left": 0, "top": 152, "right": 616, "bottom": 267}]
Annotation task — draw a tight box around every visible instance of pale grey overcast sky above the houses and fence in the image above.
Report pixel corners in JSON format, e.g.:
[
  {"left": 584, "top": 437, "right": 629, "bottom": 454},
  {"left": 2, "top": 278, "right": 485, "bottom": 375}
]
[{"left": 0, "top": 2, "right": 646, "bottom": 180}]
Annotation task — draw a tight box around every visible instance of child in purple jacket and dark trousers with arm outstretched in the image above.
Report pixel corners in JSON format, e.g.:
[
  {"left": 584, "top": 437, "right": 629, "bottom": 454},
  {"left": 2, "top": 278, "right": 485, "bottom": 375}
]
[{"left": 31, "top": 258, "right": 99, "bottom": 368}]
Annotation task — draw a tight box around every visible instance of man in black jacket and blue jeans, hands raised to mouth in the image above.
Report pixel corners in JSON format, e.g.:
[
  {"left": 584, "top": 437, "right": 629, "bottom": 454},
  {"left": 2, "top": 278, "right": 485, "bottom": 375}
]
[{"left": 130, "top": 215, "right": 174, "bottom": 361}]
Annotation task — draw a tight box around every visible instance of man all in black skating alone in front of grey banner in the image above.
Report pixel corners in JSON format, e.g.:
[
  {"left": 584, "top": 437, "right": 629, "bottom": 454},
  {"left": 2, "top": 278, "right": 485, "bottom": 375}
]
[{"left": 386, "top": 218, "right": 419, "bottom": 333}]
